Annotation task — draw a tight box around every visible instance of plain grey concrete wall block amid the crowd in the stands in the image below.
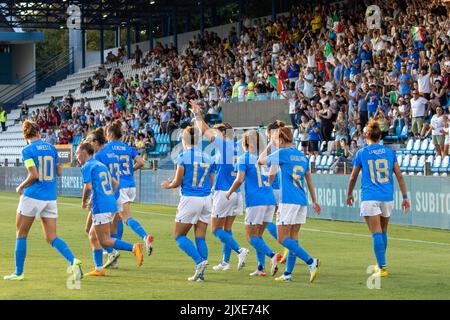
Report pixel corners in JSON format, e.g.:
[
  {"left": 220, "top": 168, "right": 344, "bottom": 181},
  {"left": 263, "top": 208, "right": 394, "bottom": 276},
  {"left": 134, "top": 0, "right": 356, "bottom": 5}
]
[{"left": 222, "top": 99, "right": 290, "bottom": 127}]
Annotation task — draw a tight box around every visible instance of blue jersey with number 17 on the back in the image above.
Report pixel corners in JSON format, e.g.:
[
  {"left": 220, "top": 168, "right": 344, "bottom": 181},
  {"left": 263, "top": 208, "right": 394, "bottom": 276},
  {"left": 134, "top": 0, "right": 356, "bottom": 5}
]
[{"left": 177, "top": 148, "right": 213, "bottom": 197}]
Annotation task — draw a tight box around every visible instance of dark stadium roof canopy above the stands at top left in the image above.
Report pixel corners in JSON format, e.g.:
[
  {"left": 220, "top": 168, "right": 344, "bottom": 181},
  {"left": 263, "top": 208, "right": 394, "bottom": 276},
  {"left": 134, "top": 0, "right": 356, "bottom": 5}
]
[{"left": 0, "top": 0, "right": 230, "bottom": 29}]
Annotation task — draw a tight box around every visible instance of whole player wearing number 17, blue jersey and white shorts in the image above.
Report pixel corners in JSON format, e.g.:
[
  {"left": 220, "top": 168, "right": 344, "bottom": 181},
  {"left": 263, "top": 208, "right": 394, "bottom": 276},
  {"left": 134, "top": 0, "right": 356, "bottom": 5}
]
[{"left": 161, "top": 127, "right": 214, "bottom": 281}]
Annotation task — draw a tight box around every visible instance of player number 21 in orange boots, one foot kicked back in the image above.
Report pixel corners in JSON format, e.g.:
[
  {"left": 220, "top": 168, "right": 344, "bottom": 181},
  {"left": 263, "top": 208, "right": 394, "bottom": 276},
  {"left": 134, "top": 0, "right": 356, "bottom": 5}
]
[{"left": 76, "top": 142, "right": 143, "bottom": 276}]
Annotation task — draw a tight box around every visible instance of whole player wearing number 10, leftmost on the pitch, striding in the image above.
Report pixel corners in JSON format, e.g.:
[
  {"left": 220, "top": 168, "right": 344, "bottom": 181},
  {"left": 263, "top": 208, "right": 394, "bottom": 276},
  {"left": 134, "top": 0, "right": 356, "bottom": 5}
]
[{"left": 3, "top": 120, "right": 83, "bottom": 281}]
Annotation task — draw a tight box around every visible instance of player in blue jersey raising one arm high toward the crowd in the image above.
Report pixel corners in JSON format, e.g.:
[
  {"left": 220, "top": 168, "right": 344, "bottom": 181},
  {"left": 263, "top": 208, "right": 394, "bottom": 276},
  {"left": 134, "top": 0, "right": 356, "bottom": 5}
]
[{"left": 191, "top": 100, "right": 249, "bottom": 271}]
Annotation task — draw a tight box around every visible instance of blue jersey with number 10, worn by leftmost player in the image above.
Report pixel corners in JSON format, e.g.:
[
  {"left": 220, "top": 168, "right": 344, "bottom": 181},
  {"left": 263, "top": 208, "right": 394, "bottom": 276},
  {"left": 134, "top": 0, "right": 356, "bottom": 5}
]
[{"left": 22, "top": 140, "right": 58, "bottom": 201}]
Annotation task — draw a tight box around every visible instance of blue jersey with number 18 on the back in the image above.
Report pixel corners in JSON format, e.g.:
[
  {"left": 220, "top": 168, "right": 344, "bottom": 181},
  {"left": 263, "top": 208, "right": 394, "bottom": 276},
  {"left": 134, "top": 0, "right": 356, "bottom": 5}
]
[{"left": 353, "top": 144, "right": 397, "bottom": 201}]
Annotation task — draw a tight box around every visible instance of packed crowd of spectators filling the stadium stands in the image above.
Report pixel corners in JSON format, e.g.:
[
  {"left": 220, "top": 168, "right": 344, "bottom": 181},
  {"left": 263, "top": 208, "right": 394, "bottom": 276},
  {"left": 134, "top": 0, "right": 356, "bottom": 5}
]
[{"left": 18, "top": 0, "right": 450, "bottom": 164}]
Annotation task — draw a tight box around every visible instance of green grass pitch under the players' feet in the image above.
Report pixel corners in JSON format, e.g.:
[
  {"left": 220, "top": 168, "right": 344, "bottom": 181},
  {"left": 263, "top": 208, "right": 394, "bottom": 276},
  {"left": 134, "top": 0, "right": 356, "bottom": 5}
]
[{"left": 0, "top": 193, "right": 450, "bottom": 300}]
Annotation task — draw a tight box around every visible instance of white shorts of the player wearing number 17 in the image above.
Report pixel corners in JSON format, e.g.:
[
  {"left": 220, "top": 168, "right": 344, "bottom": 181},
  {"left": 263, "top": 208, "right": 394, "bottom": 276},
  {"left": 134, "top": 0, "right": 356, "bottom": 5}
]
[{"left": 175, "top": 196, "right": 212, "bottom": 224}]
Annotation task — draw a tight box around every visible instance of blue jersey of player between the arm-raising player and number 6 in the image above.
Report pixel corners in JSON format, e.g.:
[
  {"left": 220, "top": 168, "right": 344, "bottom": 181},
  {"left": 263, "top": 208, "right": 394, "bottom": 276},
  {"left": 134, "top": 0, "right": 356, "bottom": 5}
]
[{"left": 238, "top": 152, "right": 276, "bottom": 207}]
